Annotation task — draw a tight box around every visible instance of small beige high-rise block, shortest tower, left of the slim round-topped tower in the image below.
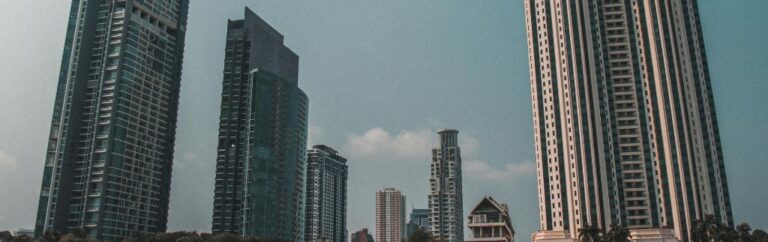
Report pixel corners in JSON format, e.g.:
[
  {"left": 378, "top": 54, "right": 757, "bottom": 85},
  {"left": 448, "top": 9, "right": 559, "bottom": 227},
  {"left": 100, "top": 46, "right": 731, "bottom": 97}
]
[{"left": 376, "top": 188, "right": 405, "bottom": 242}]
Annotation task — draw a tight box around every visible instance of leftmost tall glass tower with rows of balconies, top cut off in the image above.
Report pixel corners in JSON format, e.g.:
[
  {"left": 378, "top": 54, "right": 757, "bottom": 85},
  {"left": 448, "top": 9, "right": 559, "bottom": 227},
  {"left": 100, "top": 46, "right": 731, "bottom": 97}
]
[{"left": 35, "top": 0, "right": 188, "bottom": 240}]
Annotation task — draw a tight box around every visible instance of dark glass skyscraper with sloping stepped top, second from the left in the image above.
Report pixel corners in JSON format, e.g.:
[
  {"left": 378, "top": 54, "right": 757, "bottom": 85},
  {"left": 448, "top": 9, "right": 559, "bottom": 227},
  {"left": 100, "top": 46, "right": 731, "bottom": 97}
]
[{"left": 212, "top": 8, "right": 308, "bottom": 241}]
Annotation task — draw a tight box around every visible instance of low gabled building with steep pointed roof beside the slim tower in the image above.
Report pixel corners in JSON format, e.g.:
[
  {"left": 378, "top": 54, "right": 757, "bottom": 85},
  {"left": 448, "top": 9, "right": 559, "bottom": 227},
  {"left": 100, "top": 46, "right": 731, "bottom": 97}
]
[{"left": 467, "top": 197, "right": 515, "bottom": 242}]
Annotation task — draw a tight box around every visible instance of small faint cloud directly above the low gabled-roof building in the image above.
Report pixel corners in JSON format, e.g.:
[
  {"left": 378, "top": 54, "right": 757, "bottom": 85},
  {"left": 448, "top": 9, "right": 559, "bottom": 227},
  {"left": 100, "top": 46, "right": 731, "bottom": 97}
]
[{"left": 463, "top": 160, "right": 536, "bottom": 181}]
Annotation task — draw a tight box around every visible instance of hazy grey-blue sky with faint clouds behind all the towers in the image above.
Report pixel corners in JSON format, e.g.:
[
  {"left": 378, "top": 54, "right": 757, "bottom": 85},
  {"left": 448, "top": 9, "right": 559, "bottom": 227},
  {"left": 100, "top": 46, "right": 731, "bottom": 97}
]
[{"left": 0, "top": 0, "right": 768, "bottom": 240}]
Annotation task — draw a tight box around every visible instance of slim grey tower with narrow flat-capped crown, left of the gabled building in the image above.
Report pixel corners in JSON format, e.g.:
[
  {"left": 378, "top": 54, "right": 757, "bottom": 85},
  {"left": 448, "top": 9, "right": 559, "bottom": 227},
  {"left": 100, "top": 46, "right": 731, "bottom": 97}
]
[{"left": 428, "top": 129, "right": 464, "bottom": 242}]
